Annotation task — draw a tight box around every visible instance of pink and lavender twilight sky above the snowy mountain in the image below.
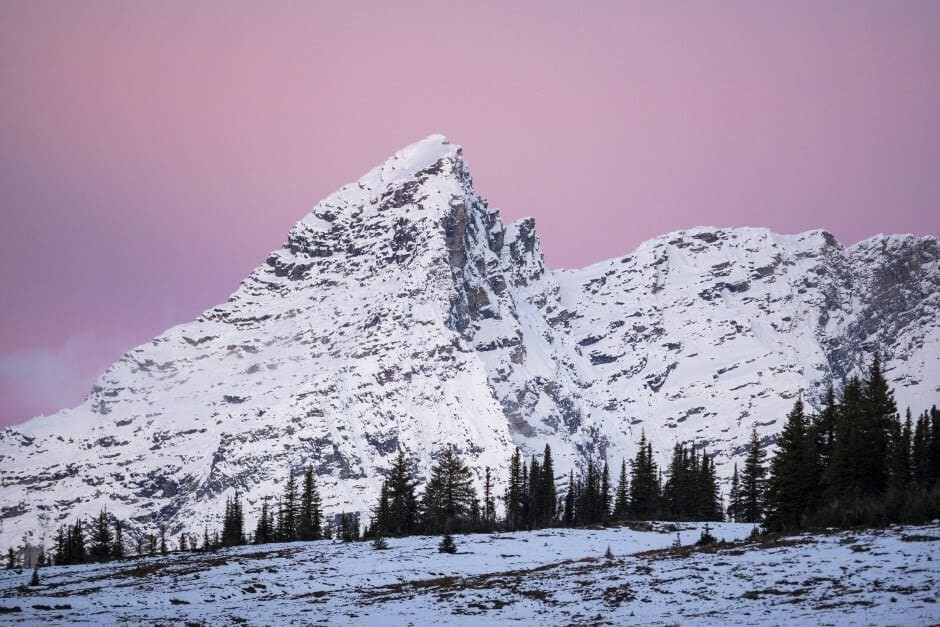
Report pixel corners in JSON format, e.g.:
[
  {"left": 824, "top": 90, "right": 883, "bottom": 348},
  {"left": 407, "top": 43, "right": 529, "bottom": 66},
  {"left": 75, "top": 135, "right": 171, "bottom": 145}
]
[{"left": 0, "top": 0, "right": 940, "bottom": 426}]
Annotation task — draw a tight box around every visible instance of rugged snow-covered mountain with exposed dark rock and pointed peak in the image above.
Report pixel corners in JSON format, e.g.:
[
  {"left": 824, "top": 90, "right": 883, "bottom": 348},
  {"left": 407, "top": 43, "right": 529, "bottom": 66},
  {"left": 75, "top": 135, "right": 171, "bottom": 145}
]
[{"left": 0, "top": 135, "right": 940, "bottom": 546}]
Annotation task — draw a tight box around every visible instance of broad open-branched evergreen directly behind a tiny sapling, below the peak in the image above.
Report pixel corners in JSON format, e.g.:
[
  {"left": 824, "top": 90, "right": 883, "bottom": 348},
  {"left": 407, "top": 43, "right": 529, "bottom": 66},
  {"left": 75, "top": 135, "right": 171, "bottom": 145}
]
[{"left": 422, "top": 448, "right": 476, "bottom": 533}]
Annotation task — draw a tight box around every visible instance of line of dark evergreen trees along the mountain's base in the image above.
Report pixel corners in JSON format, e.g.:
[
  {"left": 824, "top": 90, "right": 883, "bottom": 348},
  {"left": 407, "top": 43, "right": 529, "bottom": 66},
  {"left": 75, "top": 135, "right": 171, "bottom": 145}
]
[{"left": 7, "top": 357, "right": 940, "bottom": 567}]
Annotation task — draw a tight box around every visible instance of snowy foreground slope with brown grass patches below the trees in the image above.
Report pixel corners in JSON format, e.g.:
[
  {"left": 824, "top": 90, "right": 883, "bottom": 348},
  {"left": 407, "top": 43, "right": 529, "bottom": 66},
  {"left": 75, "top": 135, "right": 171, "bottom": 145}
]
[{"left": 0, "top": 523, "right": 940, "bottom": 626}]
